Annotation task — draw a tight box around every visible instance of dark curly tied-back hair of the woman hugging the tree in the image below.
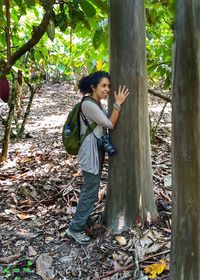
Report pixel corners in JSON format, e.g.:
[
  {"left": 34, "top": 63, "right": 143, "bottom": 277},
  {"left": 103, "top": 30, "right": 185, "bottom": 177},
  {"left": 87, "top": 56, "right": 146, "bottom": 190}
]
[{"left": 78, "top": 71, "right": 110, "bottom": 93}]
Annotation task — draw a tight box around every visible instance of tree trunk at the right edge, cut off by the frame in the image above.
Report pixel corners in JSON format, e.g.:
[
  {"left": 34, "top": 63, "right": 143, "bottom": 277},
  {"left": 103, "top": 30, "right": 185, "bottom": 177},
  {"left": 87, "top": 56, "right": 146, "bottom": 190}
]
[{"left": 170, "top": 0, "right": 200, "bottom": 280}]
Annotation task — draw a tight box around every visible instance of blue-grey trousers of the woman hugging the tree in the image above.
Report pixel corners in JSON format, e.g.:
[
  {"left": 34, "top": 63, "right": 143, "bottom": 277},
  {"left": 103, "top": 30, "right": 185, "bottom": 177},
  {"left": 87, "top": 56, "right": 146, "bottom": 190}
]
[{"left": 69, "top": 171, "right": 101, "bottom": 232}]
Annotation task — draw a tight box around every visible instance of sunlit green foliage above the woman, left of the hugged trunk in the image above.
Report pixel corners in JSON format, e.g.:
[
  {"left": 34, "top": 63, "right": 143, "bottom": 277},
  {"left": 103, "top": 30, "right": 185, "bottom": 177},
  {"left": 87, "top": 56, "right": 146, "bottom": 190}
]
[{"left": 0, "top": 0, "right": 108, "bottom": 81}]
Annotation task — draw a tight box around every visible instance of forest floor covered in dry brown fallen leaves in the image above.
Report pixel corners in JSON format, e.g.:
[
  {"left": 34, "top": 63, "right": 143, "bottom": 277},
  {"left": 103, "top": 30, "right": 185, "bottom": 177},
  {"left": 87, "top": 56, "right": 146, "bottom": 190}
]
[{"left": 0, "top": 83, "right": 172, "bottom": 280}]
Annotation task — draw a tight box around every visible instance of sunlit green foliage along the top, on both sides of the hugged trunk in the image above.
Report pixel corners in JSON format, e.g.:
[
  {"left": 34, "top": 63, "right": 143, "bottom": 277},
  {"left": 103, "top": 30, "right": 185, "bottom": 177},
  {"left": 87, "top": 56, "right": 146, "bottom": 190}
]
[{"left": 0, "top": 0, "right": 174, "bottom": 88}]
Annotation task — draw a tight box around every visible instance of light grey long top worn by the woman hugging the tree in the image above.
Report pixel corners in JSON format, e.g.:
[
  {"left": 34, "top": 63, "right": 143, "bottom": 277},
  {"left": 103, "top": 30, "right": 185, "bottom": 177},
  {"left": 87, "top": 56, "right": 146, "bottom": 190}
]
[{"left": 77, "top": 100, "right": 113, "bottom": 175}]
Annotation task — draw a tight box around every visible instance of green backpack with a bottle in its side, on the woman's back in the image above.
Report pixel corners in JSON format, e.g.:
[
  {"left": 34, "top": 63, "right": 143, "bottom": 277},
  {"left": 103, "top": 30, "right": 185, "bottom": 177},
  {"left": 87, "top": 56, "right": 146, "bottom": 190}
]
[{"left": 62, "top": 97, "right": 97, "bottom": 156}]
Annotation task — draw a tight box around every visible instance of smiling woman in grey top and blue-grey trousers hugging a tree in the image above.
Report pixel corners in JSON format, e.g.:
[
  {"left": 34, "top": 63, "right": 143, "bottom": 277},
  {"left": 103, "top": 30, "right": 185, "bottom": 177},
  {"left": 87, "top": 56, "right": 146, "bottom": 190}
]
[{"left": 66, "top": 71, "right": 129, "bottom": 244}]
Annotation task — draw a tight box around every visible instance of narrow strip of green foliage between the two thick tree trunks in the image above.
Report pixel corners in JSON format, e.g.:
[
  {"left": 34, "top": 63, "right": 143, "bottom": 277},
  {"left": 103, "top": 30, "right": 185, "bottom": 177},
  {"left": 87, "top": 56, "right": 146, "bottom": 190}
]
[{"left": 146, "top": 0, "right": 175, "bottom": 89}]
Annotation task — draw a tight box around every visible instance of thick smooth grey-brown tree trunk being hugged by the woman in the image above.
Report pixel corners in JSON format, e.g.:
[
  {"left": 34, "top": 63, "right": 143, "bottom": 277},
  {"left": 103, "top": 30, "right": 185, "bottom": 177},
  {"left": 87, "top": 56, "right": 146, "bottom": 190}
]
[{"left": 106, "top": 0, "right": 157, "bottom": 233}]
